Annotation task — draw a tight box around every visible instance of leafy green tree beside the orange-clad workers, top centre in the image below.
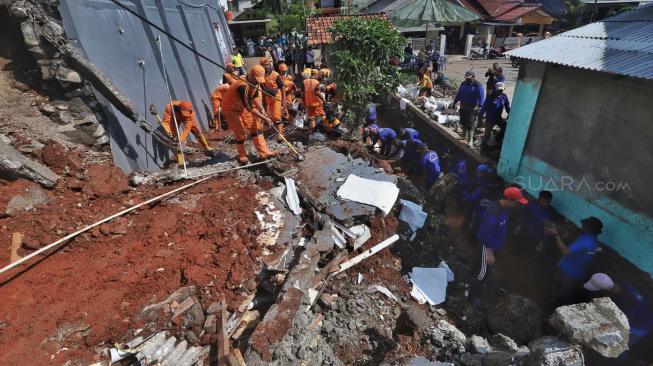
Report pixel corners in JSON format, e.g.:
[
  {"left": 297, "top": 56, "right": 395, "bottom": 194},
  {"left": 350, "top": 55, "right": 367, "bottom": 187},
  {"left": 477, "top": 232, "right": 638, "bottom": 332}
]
[{"left": 327, "top": 17, "right": 406, "bottom": 131}]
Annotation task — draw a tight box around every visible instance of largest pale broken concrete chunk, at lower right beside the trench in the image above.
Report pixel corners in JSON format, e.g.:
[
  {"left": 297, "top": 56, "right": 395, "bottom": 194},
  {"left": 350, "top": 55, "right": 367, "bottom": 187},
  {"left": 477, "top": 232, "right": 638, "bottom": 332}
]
[{"left": 549, "top": 297, "right": 630, "bottom": 358}]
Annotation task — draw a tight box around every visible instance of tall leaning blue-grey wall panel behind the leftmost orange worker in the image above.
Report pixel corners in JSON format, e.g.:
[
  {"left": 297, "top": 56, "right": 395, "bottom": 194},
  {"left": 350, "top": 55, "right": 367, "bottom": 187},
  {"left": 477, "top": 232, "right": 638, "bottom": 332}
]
[{"left": 60, "top": 0, "right": 232, "bottom": 172}]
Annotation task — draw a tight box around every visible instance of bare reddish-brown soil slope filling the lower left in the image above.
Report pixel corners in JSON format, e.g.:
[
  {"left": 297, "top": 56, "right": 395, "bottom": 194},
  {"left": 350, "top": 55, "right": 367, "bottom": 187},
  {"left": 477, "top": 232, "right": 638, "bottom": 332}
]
[{"left": 0, "top": 175, "right": 268, "bottom": 365}]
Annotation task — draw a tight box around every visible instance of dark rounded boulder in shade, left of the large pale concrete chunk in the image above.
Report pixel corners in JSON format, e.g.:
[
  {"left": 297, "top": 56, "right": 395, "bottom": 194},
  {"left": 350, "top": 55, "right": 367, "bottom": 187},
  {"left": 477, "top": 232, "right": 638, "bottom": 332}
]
[{"left": 486, "top": 295, "right": 541, "bottom": 343}]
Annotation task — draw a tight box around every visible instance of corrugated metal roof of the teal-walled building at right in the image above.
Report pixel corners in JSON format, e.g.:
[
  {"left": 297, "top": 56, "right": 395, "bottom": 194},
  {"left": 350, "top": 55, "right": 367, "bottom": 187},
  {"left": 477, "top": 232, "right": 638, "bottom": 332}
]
[{"left": 508, "top": 4, "right": 653, "bottom": 79}]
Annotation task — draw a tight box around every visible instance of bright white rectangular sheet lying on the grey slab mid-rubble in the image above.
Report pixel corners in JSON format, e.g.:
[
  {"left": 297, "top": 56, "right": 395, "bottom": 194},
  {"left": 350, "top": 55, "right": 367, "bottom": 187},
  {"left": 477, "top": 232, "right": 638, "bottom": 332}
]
[{"left": 337, "top": 174, "right": 399, "bottom": 215}]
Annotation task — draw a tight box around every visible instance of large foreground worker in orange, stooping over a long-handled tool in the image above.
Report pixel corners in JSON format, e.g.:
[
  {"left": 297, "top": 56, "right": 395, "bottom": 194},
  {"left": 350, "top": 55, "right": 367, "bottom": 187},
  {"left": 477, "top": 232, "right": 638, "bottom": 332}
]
[{"left": 222, "top": 65, "right": 277, "bottom": 164}]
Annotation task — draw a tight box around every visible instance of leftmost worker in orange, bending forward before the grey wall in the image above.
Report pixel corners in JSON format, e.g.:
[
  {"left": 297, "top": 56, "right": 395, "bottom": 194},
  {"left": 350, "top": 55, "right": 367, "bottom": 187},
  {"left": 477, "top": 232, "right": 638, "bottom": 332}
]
[{"left": 161, "top": 100, "right": 213, "bottom": 165}]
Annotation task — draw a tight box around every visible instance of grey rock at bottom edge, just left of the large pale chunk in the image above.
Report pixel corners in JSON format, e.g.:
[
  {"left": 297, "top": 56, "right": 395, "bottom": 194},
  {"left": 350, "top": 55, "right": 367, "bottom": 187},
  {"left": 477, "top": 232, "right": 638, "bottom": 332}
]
[{"left": 528, "top": 336, "right": 585, "bottom": 366}]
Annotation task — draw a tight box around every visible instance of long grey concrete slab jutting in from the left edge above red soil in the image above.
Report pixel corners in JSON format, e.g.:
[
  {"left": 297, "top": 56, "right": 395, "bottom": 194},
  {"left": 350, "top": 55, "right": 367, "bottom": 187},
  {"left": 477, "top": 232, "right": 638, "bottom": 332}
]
[{"left": 0, "top": 139, "right": 59, "bottom": 187}]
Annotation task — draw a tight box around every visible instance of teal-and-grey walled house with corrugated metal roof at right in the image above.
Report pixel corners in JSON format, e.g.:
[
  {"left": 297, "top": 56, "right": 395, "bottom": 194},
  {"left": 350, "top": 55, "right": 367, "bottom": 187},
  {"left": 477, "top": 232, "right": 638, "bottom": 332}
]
[{"left": 498, "top": 4, "right": 653, "bottom": 274}]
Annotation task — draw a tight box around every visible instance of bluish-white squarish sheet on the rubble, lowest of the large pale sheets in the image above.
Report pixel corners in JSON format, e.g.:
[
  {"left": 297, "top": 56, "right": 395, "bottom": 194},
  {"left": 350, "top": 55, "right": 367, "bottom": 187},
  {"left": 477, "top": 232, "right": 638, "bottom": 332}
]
[{"left": 410, "top": 267, "right": 447, "bottom": 305}]
